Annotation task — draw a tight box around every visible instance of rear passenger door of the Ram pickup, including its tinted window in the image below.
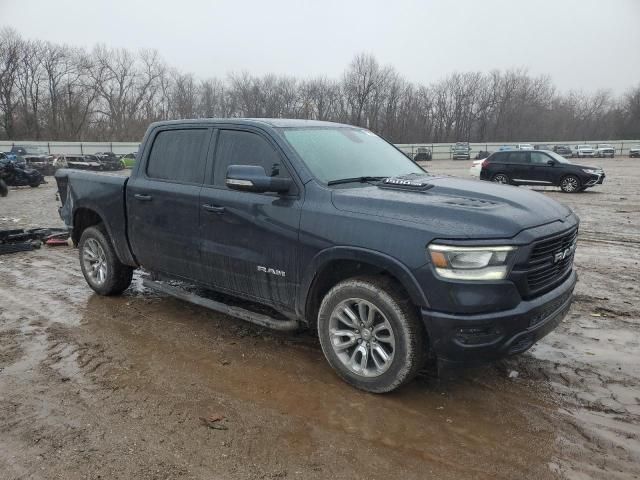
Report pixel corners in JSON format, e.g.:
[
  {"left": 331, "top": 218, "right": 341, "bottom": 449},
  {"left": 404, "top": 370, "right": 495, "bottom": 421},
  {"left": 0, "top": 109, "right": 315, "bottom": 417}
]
[{"left": 126, "top": 127, "right": 212, "bottom": 279}]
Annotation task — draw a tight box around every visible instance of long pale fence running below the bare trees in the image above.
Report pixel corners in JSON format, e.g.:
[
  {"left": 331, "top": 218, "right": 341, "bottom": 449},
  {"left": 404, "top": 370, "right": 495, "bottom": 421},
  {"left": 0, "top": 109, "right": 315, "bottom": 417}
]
[{"left": 0, "top": 140, "right": 640, "bottom": 160}]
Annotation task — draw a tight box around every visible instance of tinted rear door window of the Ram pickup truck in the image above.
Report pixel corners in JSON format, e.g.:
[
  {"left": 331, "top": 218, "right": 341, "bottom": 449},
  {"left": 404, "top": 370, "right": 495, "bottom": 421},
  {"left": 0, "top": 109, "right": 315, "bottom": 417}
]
[{"left": 147, "top": 129, "right": 209, "bottom": 183}]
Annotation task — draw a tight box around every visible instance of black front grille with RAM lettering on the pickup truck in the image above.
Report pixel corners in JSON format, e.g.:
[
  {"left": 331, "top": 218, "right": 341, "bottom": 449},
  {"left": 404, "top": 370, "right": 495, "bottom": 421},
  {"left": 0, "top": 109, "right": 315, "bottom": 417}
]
[{"left": 527, "top": 228, "right": 578, "bottom": 295}]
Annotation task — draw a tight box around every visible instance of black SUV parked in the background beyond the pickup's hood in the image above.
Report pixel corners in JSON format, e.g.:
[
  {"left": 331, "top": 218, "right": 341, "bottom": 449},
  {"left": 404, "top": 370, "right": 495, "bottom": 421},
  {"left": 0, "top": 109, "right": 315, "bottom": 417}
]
[{"left": 480, "top": 150, "right": 605, "bottom": 193}]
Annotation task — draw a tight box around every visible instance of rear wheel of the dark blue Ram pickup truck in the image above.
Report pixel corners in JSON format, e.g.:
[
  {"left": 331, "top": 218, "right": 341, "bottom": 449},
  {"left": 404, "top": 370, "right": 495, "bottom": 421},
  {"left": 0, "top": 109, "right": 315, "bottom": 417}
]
[{"left": 78, "top": 225, "right": 133, "bottom": 296}]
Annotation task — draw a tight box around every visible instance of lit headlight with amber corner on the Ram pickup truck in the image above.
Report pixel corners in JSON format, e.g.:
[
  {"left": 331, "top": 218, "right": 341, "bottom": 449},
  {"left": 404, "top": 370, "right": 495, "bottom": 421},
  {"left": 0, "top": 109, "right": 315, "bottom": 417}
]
[{"left": 429, "top": 244, "right": 516, "bottom": 280}]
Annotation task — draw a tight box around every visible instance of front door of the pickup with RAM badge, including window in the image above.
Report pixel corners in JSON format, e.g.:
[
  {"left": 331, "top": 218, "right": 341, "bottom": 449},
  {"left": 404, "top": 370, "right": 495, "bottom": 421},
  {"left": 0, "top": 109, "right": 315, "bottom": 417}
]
[{"left": 200, "top": 127, "right": 302, "bottom": 309}]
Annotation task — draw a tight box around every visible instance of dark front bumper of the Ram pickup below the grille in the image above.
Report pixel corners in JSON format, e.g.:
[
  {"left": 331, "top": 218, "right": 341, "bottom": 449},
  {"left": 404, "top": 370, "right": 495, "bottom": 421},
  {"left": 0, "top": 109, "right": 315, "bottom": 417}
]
[{"left": 421, "top": 271, "right": 577, "bottom": 366}]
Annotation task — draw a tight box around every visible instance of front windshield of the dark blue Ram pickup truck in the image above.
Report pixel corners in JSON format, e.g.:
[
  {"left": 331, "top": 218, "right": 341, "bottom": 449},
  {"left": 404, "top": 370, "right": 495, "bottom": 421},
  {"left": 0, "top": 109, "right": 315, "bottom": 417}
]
[{"left": 281, "top": 127, "right": 424, "bottom": 183}]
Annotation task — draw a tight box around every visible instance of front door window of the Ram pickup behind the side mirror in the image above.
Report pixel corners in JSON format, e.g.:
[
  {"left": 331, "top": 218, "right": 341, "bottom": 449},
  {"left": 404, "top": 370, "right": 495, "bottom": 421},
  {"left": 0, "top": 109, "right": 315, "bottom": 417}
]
[{"left": 213, "top": 130, "right": 291, "bottom": 186}]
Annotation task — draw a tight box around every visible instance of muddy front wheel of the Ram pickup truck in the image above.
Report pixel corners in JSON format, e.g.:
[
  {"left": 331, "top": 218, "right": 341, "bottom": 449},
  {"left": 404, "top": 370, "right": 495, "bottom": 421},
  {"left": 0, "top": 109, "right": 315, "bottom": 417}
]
[{"left": 318, "top": 277, "right": 428, "bottom": 393}]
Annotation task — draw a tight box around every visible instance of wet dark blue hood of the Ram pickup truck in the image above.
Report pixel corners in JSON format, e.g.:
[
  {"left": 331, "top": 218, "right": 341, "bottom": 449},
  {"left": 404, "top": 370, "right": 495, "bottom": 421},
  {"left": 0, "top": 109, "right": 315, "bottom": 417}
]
[{"left": 332, "top": 175, "right": 573, "bottom": 239}]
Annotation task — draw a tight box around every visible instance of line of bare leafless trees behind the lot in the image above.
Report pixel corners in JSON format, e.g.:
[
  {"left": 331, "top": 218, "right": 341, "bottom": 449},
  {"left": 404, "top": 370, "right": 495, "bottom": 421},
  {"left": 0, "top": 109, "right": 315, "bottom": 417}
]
[{"left": 0, "top": 28, "right": 640, "bottom": 143}]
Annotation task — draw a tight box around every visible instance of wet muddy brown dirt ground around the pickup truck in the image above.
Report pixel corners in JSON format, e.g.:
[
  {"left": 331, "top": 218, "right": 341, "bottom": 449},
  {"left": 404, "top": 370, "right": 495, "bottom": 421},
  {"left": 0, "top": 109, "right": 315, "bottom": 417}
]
[{"left": 0, "top": 159, "right": 640, "bottom": 480}]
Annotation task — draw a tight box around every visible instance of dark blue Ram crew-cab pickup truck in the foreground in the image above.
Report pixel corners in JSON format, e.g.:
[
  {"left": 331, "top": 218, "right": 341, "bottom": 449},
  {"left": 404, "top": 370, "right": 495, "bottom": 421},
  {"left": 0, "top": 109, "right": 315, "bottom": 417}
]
[{"left": 56, "top": 119, "right": 579, "bottom": 393}]
